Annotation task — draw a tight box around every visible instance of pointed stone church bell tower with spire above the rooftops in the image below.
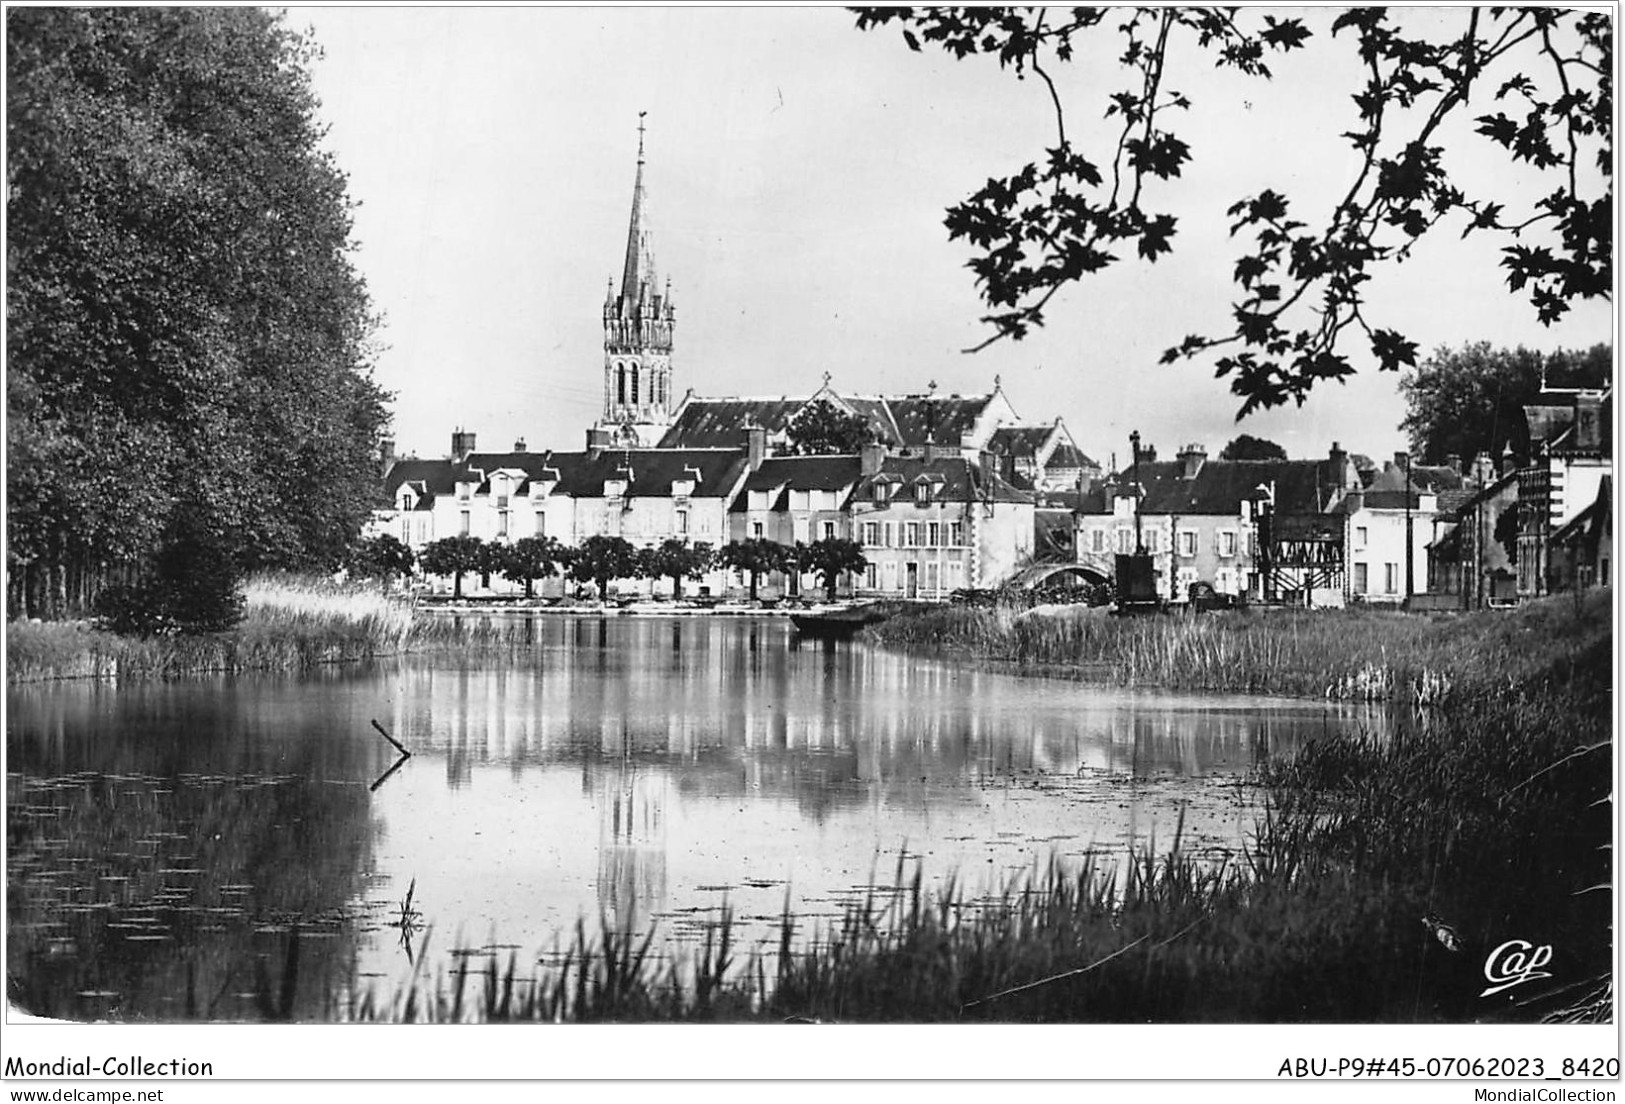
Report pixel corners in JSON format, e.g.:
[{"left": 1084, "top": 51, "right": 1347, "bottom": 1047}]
[{"left": 598, "top": 112, "right": 676, "bottom": 449}]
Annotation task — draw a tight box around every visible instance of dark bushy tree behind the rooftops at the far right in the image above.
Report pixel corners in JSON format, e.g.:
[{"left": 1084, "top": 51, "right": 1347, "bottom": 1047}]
[{"left": 1399, "top": 341, "right": 1614, "bottom": 463}]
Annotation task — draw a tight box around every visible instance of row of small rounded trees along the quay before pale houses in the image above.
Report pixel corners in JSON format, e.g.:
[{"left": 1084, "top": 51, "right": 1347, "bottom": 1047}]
[{"left": 373, "top": 533, "right": 869, "bottom": 602}]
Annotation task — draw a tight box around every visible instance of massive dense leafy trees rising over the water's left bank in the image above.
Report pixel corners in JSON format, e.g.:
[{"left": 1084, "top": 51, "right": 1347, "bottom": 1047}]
[{"left": 7, "top": 8, "right": 387, "bottom": 615}]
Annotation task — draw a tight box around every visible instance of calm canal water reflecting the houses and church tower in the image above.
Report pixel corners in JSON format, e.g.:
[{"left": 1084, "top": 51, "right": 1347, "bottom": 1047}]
[{"left": 7, "top": 616, "right": 1375, "bottom": 1019}]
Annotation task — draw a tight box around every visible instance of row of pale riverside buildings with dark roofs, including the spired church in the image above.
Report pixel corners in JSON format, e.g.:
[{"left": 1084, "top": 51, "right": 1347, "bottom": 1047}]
[{"left": 371, "top": 132, "right": 1612, "bottom": 608}]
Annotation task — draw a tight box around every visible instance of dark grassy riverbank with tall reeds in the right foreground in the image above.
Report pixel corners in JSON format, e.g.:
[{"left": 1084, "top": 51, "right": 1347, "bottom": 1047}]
[{"left": 343, "top": 593, "right": 1614, "bottom": 1023}]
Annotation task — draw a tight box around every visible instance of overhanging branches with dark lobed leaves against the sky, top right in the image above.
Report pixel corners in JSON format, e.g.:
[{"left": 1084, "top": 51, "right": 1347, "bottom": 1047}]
[{"left": 858, "top": 7, "right": 1614, "bottom": 415}]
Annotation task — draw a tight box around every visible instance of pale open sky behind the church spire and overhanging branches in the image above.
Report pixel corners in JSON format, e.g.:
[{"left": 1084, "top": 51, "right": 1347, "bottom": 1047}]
[{"left": 288, "top": 7, "right": 1614, "bottom": 463}]
